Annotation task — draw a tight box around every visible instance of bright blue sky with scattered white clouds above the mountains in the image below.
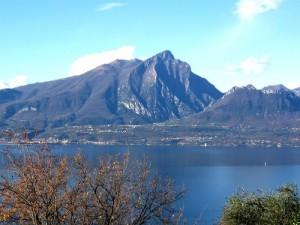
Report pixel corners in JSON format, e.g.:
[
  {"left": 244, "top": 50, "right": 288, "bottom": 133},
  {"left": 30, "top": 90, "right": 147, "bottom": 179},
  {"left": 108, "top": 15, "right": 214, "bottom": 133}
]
[{"left": 0, "top": 0, "right": 300, "bottom": 91}]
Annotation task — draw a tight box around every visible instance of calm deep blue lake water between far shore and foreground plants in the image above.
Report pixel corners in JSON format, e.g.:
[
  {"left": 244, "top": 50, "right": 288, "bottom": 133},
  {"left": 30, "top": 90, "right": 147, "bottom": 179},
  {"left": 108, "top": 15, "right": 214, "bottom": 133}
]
[{"left": 2, "top": 145, "right": 300, "bottom": 225}]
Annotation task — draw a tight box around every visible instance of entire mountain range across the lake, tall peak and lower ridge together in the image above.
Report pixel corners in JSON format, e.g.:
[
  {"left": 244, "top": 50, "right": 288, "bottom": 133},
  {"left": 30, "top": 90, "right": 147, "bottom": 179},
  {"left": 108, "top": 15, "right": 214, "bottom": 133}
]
[{"left": 0, "top": 51, "right": 300, "bottom": 129}]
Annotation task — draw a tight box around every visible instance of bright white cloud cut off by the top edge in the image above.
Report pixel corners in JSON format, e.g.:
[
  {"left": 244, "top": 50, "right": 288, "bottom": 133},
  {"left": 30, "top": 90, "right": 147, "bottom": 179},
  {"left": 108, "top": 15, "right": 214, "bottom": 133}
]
[{"left": 235, "top": 0, "right": 282, "bottom": 19}]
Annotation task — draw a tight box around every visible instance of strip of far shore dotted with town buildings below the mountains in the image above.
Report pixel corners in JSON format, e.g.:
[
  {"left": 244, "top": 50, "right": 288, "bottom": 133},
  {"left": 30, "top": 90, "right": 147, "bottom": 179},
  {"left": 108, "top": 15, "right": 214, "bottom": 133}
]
[{"left": 0, "top": 124, "right": 300, "bottom": 148}]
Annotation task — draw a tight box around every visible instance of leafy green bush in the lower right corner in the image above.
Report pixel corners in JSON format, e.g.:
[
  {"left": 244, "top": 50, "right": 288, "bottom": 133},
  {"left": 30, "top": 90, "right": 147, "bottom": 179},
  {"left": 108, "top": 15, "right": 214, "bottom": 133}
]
[{"left": 221, "top": 185, "right": 300, "bottom": 225}]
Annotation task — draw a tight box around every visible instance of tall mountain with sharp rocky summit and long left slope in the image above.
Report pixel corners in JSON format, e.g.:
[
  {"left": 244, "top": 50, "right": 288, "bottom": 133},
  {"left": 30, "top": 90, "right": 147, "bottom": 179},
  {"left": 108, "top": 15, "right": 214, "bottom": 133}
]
[{"left": 0, "top": 51, "right": 222, "bottom": 128}]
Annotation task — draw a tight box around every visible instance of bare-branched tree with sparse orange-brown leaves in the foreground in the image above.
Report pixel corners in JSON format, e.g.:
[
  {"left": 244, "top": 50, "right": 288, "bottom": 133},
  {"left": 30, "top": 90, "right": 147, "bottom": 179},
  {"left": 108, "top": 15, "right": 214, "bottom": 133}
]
[{"left": 0, "top": 146, "right": 184, "bottom": 225}]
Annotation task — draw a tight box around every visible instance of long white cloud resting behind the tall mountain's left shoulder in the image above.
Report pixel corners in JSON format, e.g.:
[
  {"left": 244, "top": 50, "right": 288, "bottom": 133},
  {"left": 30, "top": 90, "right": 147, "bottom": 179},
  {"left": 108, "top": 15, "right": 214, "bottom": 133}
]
[{"left": 69, "top": 46, "right": 135, "bottom": 76}]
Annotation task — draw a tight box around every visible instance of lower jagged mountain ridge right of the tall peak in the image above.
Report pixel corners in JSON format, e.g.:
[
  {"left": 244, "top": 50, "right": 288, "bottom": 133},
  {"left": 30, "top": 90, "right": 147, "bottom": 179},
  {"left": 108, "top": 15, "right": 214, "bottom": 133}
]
[{"left": 184, "top": 85, "right": 300, "bottom": 126}]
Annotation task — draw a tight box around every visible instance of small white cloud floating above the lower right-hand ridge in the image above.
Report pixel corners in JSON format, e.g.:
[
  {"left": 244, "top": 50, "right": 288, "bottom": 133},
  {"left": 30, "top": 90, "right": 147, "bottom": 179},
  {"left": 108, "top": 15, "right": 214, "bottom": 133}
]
[{"left": 226, "top": 56, "right": 270, "bottom": 74}]
